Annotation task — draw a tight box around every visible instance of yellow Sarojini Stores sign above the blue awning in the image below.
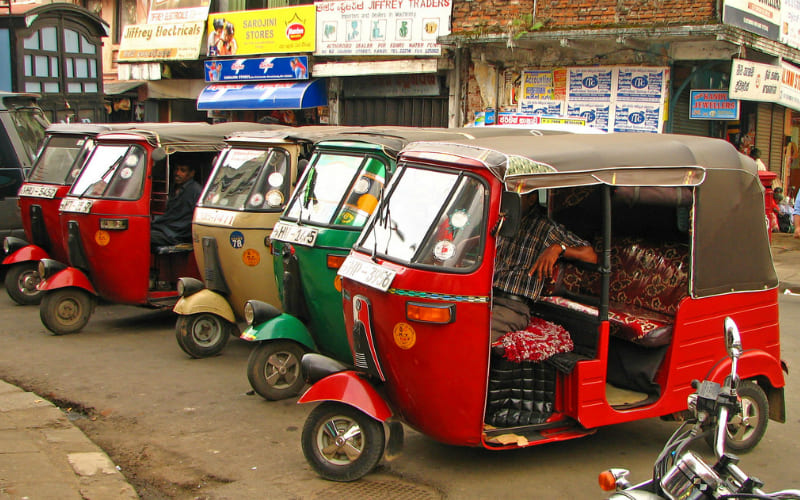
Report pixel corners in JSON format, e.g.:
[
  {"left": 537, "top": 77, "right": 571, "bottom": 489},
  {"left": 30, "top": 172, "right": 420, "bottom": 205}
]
[{"left": 207, "top": 5, "right": 316, "bottom": 57}]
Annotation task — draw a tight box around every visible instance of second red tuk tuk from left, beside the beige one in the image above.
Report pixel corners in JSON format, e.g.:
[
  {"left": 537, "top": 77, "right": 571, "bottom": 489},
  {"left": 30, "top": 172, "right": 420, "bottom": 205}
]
[{"left": 38, "top": 123, "right": 265, "bottom": 335}]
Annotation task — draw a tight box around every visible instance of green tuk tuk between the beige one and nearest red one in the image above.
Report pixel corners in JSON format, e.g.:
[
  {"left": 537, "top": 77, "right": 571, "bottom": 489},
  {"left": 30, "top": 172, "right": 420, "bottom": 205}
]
[{"left": 241, "top": 127, "right": 580, "bottom": 400}]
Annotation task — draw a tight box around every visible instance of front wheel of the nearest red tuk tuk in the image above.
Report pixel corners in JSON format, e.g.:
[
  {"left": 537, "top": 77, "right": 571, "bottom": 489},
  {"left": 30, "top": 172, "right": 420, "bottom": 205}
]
[{"left": 301, "top": 402, "right": 385, "bottom": 482}]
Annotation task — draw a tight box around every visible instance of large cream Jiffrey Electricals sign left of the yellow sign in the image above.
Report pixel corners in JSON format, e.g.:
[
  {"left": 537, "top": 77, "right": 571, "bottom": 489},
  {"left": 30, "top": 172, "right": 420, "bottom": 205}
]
[{"left": 117, "top": 21, "right": 208, "bottom": 62}]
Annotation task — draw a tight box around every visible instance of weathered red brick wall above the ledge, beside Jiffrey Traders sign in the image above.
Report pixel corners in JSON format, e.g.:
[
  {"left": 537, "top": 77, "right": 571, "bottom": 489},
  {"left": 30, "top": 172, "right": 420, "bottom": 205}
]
[{"left": 452, "top": 0, "right": 719, "bottom": 35}]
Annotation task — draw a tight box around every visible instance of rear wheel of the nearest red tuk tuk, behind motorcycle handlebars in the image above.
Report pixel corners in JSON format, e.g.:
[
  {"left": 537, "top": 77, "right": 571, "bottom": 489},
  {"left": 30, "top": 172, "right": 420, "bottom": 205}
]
[{"left": 707, "top": 380, "right": 769, "bottom": 453}]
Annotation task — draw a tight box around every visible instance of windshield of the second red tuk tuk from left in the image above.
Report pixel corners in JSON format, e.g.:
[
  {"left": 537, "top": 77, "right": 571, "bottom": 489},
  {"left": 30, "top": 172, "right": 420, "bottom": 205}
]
[{"left": 69, "top": 145, "right": 147, "bottom": 200}]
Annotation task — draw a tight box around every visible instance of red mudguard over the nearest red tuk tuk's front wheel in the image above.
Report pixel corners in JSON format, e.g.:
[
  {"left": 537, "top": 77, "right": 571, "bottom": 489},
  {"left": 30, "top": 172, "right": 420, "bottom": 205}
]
[{"left": 297, "top": 370, "right": 392, "bottom": 422}]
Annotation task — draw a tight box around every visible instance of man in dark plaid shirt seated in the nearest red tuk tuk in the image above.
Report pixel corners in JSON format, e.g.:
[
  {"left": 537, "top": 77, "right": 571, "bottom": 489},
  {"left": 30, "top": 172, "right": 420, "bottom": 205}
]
[{"left": 491, "top": 194, "right": 597, "bottom": 342}]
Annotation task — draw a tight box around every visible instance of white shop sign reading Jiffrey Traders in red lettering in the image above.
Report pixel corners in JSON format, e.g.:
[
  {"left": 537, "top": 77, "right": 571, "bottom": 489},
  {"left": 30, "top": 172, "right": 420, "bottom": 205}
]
[{"left": 314, "top": 0, "right": 452, "bottom": 56}]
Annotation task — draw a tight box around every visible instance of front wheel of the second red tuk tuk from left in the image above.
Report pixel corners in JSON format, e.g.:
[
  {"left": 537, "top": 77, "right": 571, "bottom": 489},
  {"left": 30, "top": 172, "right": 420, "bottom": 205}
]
[{"left": 39, "top": 288, "right": 95, "bottom": 335}]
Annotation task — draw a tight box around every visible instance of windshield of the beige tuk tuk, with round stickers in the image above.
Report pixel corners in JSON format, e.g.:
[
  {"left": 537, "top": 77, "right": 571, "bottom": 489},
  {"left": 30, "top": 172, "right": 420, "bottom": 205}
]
[{"left": 200, "top": 148, "right": 291, "bottom": 212}]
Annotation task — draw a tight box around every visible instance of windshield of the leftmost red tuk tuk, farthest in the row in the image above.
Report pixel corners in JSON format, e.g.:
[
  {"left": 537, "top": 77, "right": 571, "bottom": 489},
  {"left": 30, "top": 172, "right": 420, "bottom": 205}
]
[{"left": 28, "top": 135, "right": 94, "bottom": 186}]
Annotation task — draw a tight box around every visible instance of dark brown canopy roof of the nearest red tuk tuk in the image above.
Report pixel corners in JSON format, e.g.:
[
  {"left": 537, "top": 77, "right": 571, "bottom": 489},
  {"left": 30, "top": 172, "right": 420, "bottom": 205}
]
[{"left": 403, "top": 133, "right": 778, "bottom": 297}]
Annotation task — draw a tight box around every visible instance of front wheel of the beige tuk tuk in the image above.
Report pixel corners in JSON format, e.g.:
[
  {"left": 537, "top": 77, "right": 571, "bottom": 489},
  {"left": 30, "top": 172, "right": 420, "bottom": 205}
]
[{"left": 175, "top": 313, "right": 236, "bottom": 358}]
